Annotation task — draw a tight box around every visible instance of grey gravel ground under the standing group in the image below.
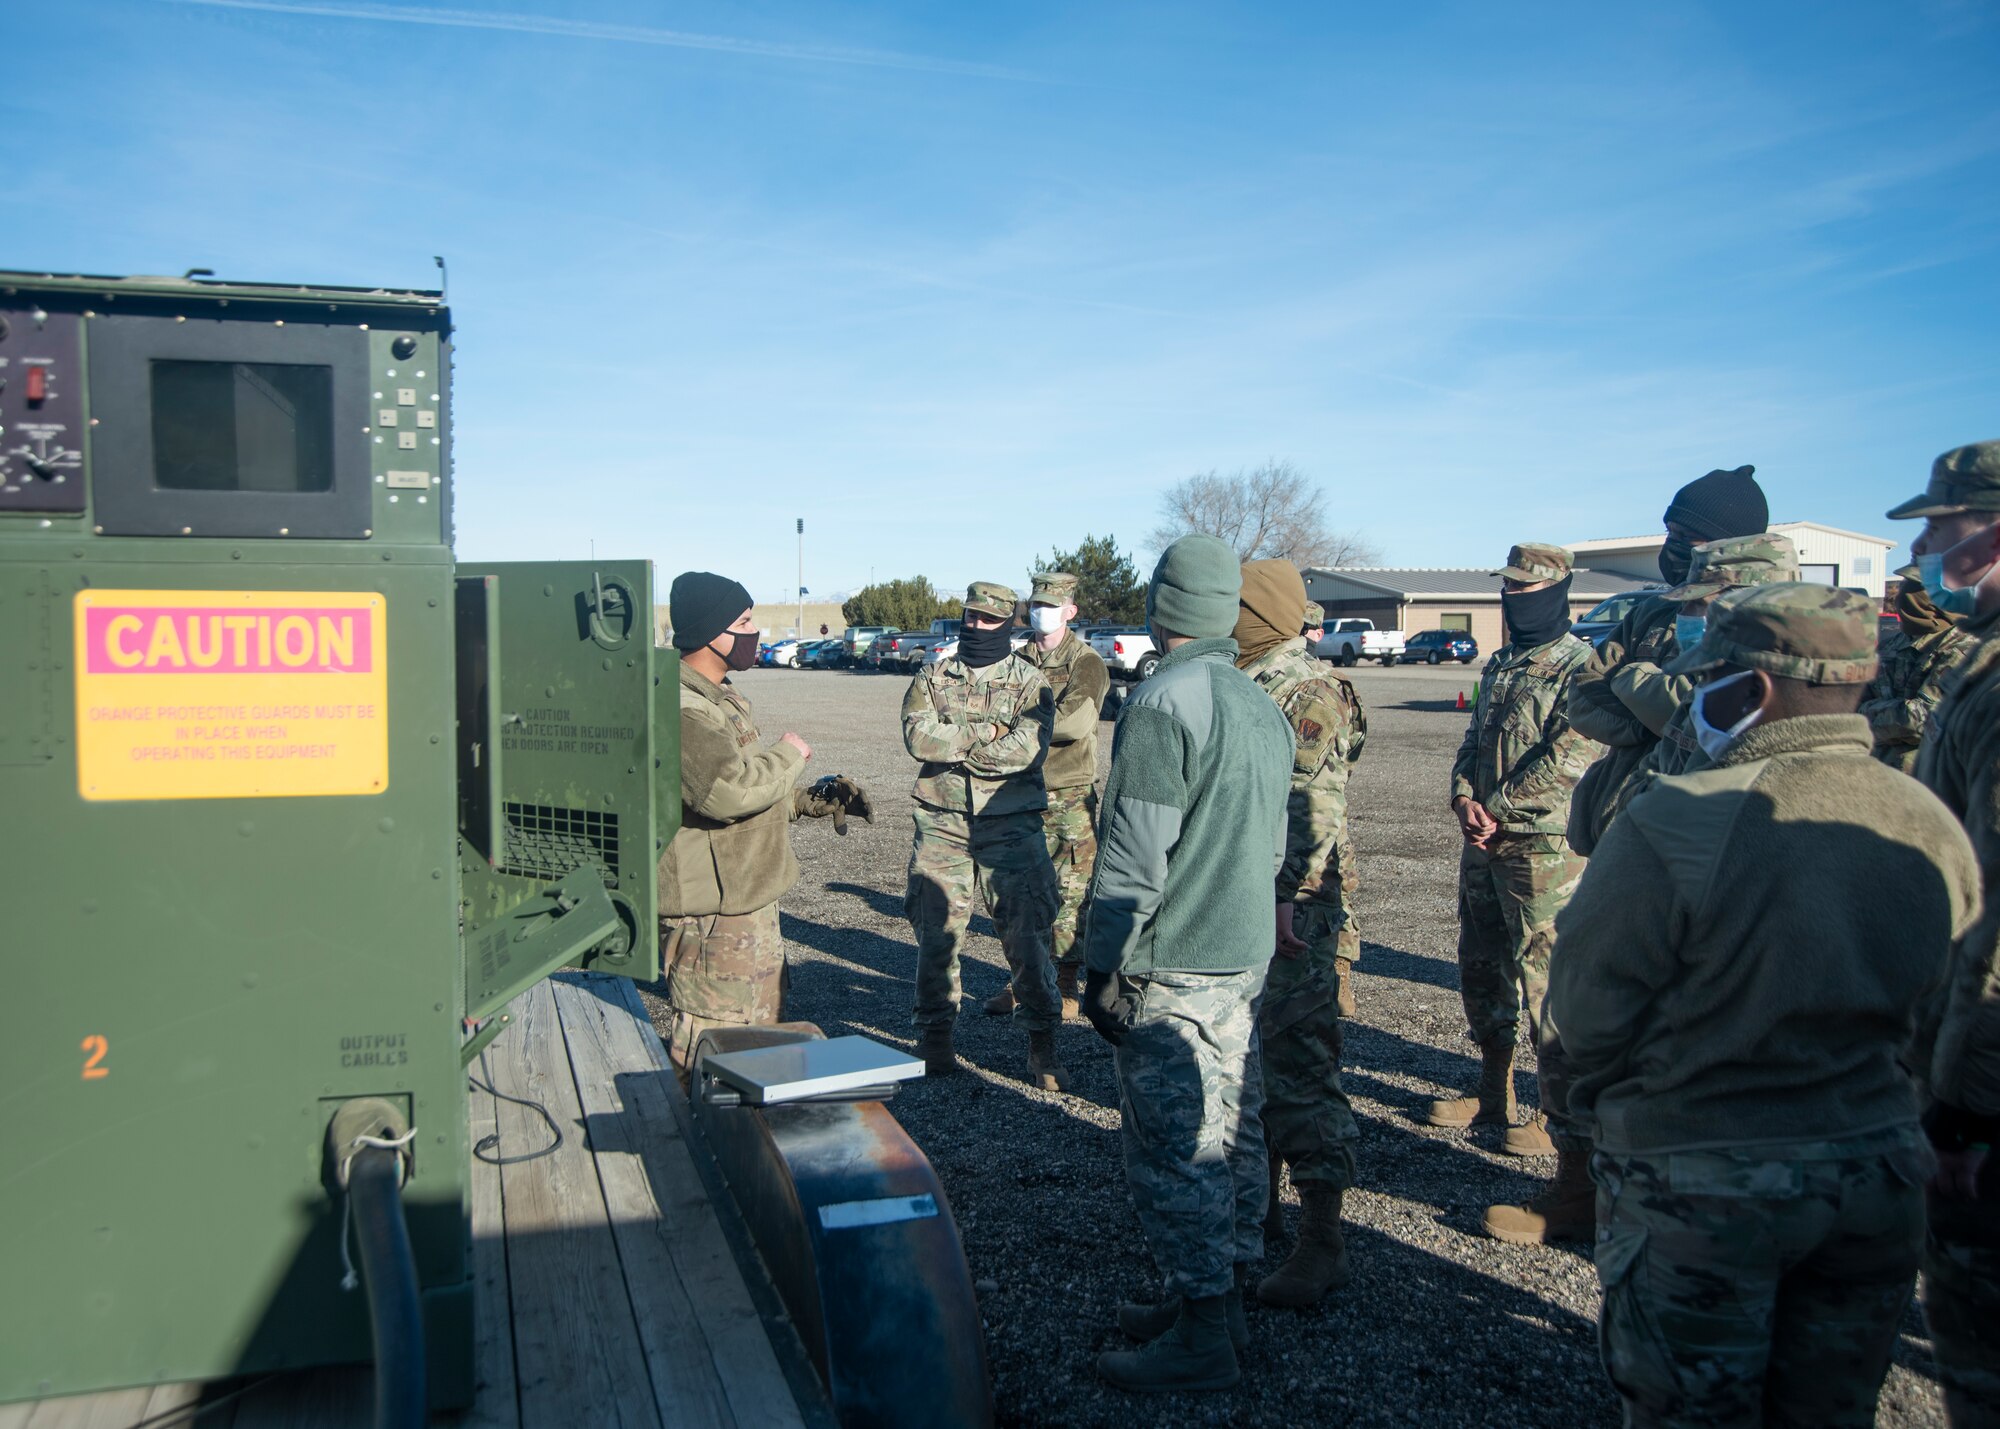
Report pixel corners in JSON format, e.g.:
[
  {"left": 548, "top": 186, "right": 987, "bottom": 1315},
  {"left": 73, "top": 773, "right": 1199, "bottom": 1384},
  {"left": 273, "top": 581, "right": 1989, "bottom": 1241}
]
[{"left": 636, "top": 666, "right": 1944, "bottom": 1427}]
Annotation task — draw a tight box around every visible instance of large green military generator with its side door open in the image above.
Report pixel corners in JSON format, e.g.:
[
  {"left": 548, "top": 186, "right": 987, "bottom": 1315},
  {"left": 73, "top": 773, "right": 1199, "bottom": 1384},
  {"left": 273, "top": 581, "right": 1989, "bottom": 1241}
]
[{"left": 0, "top": 272, "right": 680, "bottom": 1407}]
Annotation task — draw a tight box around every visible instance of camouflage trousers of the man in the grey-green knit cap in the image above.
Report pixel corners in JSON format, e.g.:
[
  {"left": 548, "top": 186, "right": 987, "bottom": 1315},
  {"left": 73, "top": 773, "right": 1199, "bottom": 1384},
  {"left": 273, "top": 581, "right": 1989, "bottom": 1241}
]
[{"left": 1114, "top": 969, "right": 1270, "bottom": 1299}]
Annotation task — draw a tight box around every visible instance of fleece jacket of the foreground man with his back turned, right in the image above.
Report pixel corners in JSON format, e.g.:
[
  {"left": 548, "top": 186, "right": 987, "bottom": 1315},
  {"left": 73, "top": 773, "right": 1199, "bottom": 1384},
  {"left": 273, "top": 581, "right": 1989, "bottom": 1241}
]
[{"left": 1548, "top": 715, "right": 1980, "bottom": 1155}]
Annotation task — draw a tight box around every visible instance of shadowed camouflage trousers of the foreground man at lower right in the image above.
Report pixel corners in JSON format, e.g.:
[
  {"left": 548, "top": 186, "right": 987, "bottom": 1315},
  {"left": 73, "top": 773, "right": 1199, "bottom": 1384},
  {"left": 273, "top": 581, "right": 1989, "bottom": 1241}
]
[{"left": 1590, "top": 1127, "right": 1932, "bottom": 1427}]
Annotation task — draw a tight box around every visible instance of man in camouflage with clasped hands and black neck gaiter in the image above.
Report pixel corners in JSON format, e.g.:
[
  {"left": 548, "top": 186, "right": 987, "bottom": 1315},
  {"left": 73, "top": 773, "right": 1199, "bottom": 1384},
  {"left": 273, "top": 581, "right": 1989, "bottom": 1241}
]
[{"left": 1430, "top": 542, "right": 1596, "bottom": 1241}]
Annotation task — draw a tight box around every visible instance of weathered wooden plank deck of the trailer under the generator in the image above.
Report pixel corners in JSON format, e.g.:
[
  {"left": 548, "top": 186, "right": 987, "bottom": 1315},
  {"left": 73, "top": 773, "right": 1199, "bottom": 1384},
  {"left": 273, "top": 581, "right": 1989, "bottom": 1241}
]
[{"left": 0, "top": 973, "right": 826, "bottom": 1429}]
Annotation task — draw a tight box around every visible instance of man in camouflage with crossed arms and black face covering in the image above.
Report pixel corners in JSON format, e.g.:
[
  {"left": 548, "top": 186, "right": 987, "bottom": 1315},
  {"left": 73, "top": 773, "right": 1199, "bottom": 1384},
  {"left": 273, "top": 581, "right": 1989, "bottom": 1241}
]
[{"left": 902, "top": 580, "right": 1066, "bottom": 1091}]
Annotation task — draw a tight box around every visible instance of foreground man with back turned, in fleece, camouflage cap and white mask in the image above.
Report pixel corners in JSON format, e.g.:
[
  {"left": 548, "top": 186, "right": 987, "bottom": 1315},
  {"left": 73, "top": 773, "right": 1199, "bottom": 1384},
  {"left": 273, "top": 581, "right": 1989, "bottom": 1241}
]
[{"left": 1548, "top": 582, "right": 1978, "bottom": 1427}]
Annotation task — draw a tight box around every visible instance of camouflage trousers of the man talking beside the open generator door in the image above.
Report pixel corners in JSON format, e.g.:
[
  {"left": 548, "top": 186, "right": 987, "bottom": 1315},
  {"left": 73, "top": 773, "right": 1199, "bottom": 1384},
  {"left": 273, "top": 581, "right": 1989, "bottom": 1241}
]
[{"left": 660, "top": 903, "right": 784, "bottom": 1077}]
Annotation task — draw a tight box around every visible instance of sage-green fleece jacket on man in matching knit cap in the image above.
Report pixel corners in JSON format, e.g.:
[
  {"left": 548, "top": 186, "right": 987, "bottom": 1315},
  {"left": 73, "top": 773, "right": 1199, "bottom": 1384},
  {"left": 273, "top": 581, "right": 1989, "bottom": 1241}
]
[{"left": 1084, "top": 638, "right": 1292, "bottom": 977}]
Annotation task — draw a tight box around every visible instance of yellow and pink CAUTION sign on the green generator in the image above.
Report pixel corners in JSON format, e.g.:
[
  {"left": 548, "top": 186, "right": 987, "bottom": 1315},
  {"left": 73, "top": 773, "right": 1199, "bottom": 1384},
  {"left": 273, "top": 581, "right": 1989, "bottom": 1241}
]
[{"left": 76, "top": 590, "right": 388, "bottom": 799}]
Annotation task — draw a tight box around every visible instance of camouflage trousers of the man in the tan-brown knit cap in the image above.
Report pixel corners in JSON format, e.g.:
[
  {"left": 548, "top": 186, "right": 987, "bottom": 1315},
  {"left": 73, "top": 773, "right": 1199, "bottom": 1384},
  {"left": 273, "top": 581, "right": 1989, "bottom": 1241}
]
[{"left": 1256, "top": 903, "right": 1362, "bottom": 1189}]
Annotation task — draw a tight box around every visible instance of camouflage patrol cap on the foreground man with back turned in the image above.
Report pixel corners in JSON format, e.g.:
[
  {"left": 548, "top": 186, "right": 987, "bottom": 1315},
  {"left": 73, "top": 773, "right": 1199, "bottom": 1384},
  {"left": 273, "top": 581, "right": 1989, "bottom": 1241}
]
[{"left": 1664, "top": 580, "right": 1876, "bottom": 684}]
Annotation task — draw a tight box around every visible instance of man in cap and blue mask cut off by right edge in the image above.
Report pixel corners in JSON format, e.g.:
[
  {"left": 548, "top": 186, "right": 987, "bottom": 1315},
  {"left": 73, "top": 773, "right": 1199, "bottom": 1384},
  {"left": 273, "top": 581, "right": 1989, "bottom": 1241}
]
[{"left": 1868, "top": 442, "right": 2000, "bottom": 1429}]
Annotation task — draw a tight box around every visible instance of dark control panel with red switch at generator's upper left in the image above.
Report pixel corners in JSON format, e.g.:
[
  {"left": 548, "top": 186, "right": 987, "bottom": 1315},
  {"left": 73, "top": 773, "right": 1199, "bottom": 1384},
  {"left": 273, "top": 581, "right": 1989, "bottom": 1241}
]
[{"left": 0, "top": 306, "right": 84, "bottom": 512}]
